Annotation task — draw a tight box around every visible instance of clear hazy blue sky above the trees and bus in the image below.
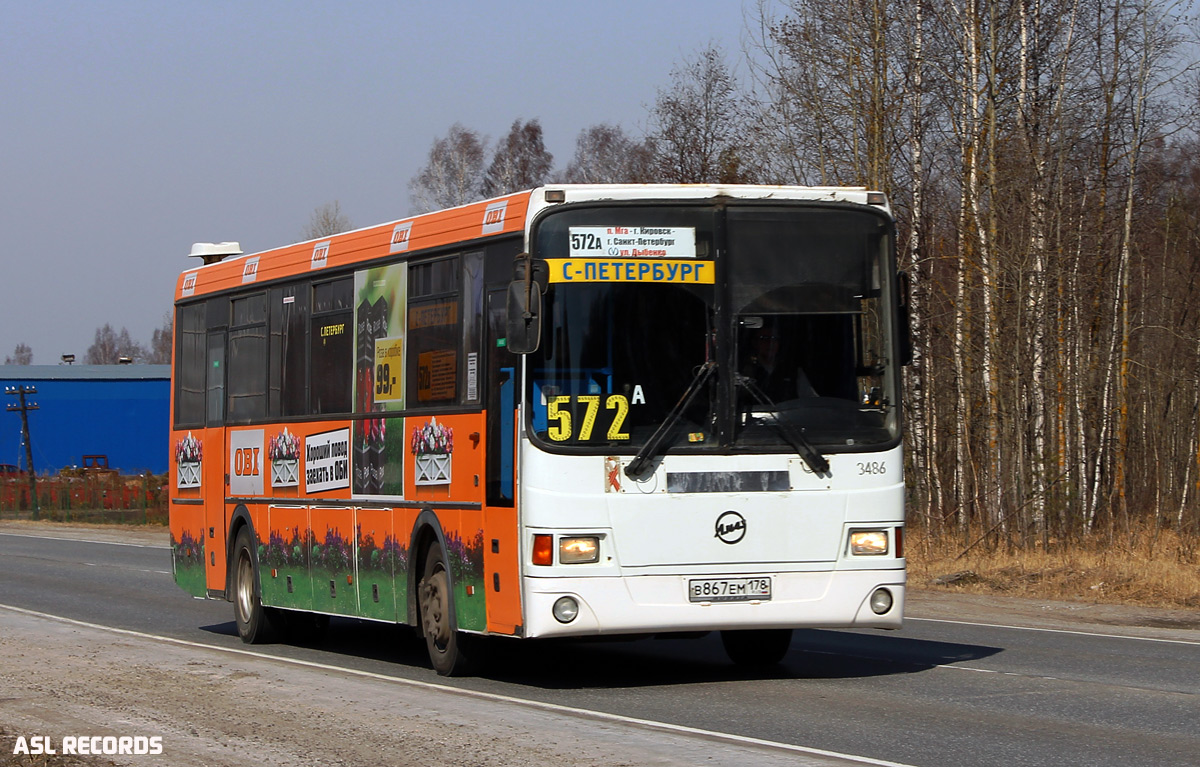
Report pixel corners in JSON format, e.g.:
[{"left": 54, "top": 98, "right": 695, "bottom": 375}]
[{"left": 0, "top": 0, "right": 756, "bottom": 365}]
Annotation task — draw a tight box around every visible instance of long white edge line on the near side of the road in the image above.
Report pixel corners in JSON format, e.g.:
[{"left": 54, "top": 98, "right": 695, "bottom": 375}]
[{"left": 0, "top": 604, "right": 916, "bottom": 767}]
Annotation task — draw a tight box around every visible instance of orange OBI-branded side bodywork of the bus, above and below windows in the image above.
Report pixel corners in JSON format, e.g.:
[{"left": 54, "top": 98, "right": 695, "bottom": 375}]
[{"left": 170, "top": 192, "right": 530, "bottom": 634}]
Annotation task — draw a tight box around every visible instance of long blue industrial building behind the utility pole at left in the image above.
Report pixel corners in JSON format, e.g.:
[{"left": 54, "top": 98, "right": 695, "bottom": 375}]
[{"left": 0, "top": 365, "right": 170, "bottom": 474}]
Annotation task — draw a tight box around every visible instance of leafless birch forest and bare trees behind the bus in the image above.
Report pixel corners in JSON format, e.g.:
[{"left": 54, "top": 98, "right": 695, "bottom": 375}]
[{"left": 8, "top": 0, "right": 1200, "bottom": 606}]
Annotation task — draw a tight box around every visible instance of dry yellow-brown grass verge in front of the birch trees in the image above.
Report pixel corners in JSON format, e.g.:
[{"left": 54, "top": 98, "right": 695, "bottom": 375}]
[{"left": 905, "top": 528, "right": 1200, "bottom": 610}]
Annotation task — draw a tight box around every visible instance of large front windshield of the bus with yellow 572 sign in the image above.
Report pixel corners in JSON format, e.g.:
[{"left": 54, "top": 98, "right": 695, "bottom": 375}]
[{"left": 527, "top": 203, "right": 899, "bottom": 454}]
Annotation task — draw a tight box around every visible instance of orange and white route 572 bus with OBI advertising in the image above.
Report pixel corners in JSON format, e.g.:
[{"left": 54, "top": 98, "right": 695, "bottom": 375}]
[{"left": 170, "top": 185, "right": 907, "bottom": 675}]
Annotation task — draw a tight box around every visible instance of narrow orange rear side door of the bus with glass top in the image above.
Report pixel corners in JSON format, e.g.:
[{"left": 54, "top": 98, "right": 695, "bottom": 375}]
[{"left": 200, "top": 330, "right": 229, "bottom": 592}]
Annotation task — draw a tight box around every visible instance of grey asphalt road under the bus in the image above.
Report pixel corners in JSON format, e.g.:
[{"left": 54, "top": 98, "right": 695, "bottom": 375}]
[{"left": 0, "top": 532, "right": 1200, "bottom": 767}]
